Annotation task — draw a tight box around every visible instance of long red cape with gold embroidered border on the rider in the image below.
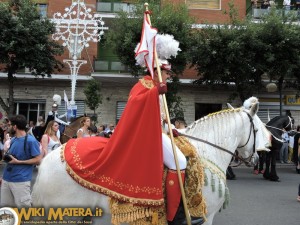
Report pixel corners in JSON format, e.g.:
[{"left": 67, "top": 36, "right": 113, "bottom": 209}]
[{"left": 64, "top": 76, "right": 163, "bottom": 206}]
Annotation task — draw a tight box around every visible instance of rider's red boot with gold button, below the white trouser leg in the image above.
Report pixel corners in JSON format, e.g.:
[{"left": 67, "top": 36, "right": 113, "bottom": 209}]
[{"left": 166, "top": 170, "right": 204, "bottom": 225}]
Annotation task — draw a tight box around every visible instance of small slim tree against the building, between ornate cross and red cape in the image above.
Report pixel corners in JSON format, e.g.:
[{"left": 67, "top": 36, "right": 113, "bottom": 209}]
[{"left": 83, "top": 79, "right": 102, "bottom": 122}]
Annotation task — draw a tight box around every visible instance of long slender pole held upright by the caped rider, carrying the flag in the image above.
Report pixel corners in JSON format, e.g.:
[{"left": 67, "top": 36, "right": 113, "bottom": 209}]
[{"left": 144, "top": 3, "right": 191, "bottom": 225}]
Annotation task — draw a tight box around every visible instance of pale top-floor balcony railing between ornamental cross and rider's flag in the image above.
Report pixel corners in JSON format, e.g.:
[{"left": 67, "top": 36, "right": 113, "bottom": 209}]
[{"left": 97, "top": 2, "right": 135, "bottom": 13}]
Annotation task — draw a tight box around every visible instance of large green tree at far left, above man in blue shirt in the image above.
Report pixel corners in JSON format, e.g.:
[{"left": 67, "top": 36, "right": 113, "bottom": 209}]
[{"left": 0, "top": 0, "right": 63, "bottom": 115}]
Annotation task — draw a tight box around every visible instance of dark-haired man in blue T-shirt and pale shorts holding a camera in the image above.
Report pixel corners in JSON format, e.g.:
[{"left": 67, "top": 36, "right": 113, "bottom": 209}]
[{"left": 1, "top": 115, "right": 41, "bottom": 208}]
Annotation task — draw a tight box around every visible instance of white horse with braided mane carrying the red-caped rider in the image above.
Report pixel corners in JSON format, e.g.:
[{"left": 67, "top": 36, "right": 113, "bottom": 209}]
[{"left": 33, "top": 104, "right": 258, "bottom": 225}]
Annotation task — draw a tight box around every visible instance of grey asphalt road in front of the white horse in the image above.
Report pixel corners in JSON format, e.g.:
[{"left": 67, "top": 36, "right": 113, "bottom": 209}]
[{"left": 0, "top": 164, "right": 300, "bottom": 225}]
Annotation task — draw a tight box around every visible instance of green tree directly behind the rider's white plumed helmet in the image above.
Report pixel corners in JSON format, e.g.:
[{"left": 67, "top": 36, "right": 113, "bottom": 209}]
[{"left": 106, "top": 1, "right": 194, "bottom": 116}]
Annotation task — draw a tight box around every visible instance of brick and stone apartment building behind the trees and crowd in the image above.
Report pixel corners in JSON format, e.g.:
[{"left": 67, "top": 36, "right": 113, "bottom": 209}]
[{"left": 0, "top": 0, "right": 300, "bottom": 124}]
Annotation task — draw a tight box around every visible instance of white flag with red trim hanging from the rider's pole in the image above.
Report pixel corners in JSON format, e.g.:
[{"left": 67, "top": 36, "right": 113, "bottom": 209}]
[{"left": 135, "top": 13, "right": 157, "bottom": 78}]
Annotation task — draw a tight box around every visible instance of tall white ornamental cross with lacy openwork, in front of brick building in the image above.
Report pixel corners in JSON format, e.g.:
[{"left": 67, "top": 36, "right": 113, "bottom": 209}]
[{"left": 52, "top": 0, "right": 108, "bottom": 104}]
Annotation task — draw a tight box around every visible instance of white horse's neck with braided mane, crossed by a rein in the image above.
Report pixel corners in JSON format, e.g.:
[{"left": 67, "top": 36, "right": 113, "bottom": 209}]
[{"left": 186, "top": 112, "right": 244, "bottom": 171}]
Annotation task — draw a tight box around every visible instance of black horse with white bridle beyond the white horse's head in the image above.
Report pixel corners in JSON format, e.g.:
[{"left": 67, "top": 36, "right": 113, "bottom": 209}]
[{"left": 264, "top": 116, "right": 293, "bottom": 181}]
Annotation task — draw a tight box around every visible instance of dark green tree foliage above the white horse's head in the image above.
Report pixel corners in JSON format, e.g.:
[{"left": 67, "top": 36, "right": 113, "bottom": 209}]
[{"left": 190, "top": 2, "right": 300, "bottom": 101}]
